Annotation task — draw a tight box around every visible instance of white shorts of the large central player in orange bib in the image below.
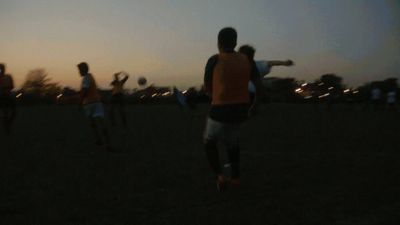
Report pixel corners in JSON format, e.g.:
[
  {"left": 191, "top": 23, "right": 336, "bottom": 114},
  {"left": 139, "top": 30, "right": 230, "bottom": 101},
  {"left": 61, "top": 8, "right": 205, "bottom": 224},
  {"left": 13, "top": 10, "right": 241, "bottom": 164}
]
[{"left": 204, "top": 118, "right": 240, "bottom": 147}]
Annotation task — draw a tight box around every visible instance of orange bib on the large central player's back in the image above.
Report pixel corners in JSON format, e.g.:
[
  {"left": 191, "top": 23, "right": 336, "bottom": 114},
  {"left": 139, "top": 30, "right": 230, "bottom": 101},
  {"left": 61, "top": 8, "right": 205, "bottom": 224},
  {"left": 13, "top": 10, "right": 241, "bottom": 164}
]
[{"left": 211, "top": 52, "right": 252, "bottom": 105}]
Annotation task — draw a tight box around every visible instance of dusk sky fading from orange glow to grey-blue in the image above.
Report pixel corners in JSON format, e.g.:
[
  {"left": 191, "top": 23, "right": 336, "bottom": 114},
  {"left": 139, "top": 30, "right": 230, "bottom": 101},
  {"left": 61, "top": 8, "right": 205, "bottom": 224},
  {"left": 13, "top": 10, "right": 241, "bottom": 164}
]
[{"left": 0, "top": 0, "right": 400, "bottom": 88}]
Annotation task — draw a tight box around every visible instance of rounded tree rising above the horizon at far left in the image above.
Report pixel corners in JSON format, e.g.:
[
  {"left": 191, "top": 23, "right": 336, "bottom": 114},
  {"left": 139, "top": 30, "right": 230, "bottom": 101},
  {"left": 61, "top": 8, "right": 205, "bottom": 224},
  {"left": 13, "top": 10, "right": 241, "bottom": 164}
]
[{"left": 22, "top": 69, "right": 62, "bottom": 97}]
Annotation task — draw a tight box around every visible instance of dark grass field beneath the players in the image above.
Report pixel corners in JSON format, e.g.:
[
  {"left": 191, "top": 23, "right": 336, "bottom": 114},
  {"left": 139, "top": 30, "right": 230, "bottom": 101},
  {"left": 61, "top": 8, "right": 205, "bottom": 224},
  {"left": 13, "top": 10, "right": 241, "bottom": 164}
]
[{"left": 0, "top": 104, "right": 400, "bottom": 225}]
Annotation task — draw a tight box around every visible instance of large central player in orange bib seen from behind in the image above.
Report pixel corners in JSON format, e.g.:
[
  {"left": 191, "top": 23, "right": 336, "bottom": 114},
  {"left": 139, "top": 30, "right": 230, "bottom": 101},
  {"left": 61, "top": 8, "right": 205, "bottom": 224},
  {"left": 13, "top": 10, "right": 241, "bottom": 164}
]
[{"left": 204, "top": 27, "right": 262, "bottom": 191}]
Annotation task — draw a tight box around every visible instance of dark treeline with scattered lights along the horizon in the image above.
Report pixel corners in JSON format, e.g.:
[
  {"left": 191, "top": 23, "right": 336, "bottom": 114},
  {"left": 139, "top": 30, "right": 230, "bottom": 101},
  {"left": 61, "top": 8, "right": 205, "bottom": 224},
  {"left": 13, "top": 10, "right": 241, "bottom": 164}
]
[{"left": 10, "top": 69, "right": 399, "bottom": 104}]
